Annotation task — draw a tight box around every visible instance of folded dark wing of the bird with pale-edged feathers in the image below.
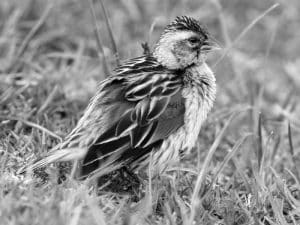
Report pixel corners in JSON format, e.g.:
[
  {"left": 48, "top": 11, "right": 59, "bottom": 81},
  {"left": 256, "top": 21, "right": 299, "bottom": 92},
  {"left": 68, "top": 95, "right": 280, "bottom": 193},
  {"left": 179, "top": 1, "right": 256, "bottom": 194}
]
[{"left": 83, "top": 66, "right": 185, "bottom": 175}]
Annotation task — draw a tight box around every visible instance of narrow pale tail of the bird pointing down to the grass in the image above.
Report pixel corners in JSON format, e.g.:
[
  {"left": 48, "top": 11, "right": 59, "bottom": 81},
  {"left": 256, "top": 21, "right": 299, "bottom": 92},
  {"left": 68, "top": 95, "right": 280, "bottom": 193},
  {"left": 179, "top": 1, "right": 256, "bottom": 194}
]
[{"left": 26, "top": 148, "right": 87, "bottom": 171}]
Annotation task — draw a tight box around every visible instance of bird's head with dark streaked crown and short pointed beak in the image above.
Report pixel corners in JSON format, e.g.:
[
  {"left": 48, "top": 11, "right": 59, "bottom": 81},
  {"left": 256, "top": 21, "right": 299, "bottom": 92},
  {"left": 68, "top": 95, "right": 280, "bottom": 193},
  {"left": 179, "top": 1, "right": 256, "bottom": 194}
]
[{"left": 153, "top": 16, "right": 219, "bottom": 69}]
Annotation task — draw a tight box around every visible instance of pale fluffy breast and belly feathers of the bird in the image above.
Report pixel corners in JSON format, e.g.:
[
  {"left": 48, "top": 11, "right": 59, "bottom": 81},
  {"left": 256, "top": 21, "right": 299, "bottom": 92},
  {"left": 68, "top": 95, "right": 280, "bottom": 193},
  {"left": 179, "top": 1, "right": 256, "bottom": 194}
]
[{"left": 153, "top": 64, "right": 216, "bottom": 171}]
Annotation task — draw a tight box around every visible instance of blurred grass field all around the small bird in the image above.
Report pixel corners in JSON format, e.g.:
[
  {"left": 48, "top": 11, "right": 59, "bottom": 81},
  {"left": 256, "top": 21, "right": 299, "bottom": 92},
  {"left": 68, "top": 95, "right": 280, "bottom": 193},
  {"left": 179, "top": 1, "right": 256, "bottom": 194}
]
[{"left": 0, "top": 0, "right": 300, "bottom": 225}]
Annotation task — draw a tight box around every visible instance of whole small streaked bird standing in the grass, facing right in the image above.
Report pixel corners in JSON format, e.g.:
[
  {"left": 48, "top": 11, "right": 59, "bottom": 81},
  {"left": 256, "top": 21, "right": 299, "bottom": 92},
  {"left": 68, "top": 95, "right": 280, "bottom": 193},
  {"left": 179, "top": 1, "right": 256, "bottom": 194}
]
[{"left": 30, "top": 16, "right": 218, "bottom": 178}]
